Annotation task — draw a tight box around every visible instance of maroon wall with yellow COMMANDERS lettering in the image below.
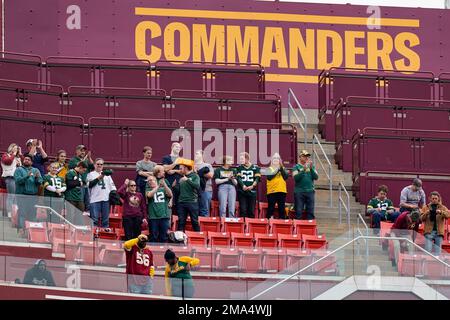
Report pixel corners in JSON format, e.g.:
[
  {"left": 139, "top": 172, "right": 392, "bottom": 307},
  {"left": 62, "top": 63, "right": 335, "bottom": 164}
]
[{"left": 4, "top": 0, "right": 450, "bottom": 108}]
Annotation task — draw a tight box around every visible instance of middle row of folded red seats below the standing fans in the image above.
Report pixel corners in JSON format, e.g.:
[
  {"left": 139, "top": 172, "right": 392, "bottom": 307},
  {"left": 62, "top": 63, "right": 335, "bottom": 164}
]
[{"left": 186, "top": 231, "right": 327, "bottom": 249}]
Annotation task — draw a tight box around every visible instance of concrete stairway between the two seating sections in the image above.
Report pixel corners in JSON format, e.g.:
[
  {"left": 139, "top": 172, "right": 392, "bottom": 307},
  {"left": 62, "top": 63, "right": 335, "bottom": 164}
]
[{"left": 282, "top": 110, "right": 398, "bottom": 276}]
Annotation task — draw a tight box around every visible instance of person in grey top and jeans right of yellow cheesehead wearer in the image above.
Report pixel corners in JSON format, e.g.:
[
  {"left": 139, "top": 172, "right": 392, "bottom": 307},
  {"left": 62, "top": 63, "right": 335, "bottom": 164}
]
[{"left": 194, "top": 150, "right": 214, "bottom": 217}]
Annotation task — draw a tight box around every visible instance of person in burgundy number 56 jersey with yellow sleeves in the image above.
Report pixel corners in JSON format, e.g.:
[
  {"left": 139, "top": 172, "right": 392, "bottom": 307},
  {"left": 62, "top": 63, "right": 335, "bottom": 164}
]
[{"left": 123, "top": 234, "right": 155, "bottom": 294}]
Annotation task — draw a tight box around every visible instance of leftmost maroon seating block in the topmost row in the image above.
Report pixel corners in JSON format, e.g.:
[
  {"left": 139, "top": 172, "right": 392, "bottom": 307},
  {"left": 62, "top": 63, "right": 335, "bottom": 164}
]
[{"left": 0, "top": 52, "right": 42, "bottom": 82}]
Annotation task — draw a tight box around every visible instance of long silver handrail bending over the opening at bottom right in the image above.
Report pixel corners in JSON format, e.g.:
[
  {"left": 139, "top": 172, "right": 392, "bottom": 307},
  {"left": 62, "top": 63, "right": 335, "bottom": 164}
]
[{"left": 249, "top": 236, "right": 450, "bottom": 300}]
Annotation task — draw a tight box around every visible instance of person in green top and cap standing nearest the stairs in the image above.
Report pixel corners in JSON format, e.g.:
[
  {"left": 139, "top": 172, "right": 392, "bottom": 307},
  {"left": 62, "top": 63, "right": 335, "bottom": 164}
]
[{"left": 292, "top": 150, "right": 319, "bottom": 220}]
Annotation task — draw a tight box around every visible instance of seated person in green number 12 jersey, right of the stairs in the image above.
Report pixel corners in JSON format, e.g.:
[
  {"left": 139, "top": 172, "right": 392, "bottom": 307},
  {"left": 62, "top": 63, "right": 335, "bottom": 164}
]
[{"left": 367, "top": 185, "right": 400, "bottom": 234}]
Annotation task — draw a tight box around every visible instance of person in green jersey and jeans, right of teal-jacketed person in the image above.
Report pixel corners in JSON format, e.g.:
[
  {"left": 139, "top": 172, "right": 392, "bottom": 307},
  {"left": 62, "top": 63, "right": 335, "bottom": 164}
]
[{"left": 43, "top": 162, "right": 67, "bottom": 223}]
